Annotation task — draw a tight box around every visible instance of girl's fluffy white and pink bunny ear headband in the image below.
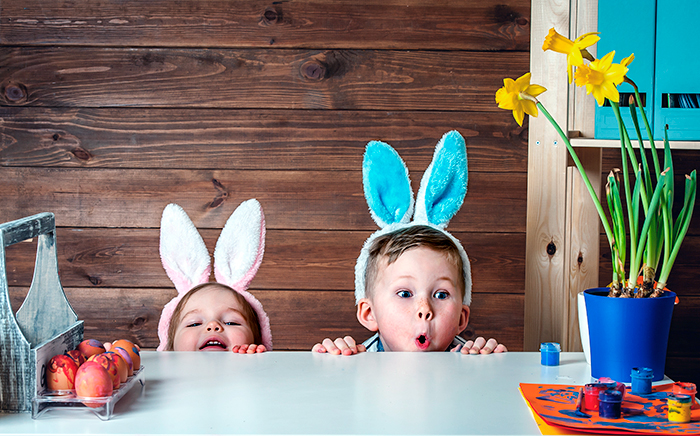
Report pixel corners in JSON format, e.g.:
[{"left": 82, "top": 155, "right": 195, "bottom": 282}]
[{"left": 158, "top": 199, "right": 272, "bottom": 351}]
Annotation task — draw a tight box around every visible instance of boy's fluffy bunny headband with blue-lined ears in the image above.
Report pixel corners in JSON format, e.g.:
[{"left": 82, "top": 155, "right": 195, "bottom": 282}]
[{"left": 355, "top": 130, "right": 472, "bottom": 305}]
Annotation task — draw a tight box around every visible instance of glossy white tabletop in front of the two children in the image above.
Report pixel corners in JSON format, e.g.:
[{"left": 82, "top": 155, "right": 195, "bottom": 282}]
[{"left": 0, "top": 351, "right": 668, "bottom": 434}]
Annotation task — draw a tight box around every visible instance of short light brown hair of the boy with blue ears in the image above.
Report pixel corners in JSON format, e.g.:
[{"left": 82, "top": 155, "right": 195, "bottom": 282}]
[{"left": 365, "top": 225, "right": 465, "bottom": 298}]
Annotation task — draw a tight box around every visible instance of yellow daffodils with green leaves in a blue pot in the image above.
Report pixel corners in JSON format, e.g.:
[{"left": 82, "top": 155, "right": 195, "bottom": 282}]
[{"left": 496, "top": 29, "right": 697, "bottom": 382}]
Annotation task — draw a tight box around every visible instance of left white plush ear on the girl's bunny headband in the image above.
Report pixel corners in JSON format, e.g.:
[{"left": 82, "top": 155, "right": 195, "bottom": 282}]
[{"left": 160, "top": 203, "right": 211, "bottom": 294}]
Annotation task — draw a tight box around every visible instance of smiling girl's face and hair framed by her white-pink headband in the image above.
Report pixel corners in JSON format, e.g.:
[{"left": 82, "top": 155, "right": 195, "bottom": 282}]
[{"left": 173, "top": 284, "right": 253, "bottom": 351}]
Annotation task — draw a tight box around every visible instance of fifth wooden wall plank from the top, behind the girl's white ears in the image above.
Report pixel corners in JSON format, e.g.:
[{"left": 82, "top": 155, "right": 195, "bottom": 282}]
[{"left": 0, "top": 228, "right": 525, "bottom": 294}]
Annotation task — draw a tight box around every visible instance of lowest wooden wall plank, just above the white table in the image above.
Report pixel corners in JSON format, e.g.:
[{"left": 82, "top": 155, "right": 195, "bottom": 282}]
[{"left": 10, "top": 287, "right": 523, "bottom": 351}]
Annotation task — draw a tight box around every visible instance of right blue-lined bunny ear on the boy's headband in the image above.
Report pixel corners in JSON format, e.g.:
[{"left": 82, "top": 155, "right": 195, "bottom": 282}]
[{"left": 415, "top": 130, "right": 468, "bottom": 228}]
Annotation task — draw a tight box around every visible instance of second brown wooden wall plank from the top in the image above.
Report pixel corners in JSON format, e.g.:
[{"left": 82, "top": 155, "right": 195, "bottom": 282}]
[{"left": 0, "top": 46, "right": 528, "bottom": 112}]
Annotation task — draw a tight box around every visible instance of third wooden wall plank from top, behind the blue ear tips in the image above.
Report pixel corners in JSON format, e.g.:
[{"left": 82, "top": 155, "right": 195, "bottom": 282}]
[{"left": 0, "top": 107, "right": 527, "bottom": 173}]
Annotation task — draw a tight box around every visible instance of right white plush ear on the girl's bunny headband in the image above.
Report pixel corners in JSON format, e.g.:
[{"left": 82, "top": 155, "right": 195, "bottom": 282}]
[{"left": 214, "top": 199, "right": 265, "bottom": 291}]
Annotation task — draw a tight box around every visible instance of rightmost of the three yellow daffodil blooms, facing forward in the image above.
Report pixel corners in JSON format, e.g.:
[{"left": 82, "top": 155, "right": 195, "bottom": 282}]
[{"left": 576, "top": 51, "right": 634, "bottom": 106}]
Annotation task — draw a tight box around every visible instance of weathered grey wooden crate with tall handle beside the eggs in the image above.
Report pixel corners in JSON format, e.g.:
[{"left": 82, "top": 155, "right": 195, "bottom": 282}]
[{"left": 0, "top": 212, "right": 83, "bottom": 412}]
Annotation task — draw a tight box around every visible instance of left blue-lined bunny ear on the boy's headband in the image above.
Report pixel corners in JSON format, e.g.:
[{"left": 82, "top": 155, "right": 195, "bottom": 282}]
[{"left": 362, "top": 141, "right": 413, "bottom": 228}]
